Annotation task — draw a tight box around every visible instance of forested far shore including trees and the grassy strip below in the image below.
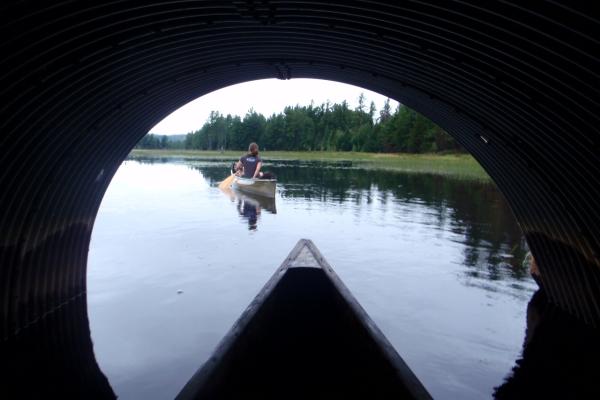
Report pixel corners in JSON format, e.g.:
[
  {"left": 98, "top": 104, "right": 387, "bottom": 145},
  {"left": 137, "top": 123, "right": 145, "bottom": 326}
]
[{"left": 131, "top": 94, "right": 489, "bottom": 180}]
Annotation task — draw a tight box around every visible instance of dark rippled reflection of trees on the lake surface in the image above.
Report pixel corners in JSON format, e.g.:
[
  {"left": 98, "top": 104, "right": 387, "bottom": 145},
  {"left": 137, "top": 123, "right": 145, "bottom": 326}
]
[{"left": 186, "top": 161, "right": 528, "bottom": 280}]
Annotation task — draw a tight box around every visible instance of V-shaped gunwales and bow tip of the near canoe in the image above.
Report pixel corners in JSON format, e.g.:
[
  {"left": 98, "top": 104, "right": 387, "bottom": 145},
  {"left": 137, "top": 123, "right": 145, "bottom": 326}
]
[{"left": 177, "top": 239, "right": 431, "bottom": 399}]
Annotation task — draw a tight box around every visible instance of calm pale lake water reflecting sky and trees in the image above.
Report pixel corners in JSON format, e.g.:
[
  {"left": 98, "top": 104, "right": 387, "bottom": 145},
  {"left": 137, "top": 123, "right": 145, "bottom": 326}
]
[{"left": 88, "top": 159, "right": 537, "bottom": 399}]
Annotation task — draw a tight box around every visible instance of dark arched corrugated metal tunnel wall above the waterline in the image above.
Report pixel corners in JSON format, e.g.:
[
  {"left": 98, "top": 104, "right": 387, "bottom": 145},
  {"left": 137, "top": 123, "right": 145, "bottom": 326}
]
[{"left": 0, "top": 0, "right": 600, "bottom": 396}]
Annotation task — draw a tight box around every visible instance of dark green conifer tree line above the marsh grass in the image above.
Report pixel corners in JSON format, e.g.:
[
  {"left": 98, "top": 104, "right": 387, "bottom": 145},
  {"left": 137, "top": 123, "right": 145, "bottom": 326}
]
[{"left": 138, "top": 94, "right": 463, "bottom": 153}]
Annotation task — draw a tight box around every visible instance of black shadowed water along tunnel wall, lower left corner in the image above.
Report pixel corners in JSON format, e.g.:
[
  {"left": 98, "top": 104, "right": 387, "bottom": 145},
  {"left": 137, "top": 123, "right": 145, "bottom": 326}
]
[{"left": 0, "top": 294, "right": 116, "bottom": 400}]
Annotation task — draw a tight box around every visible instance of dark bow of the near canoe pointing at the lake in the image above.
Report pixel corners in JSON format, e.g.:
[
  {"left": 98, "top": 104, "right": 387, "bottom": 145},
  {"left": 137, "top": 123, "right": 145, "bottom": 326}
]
[{"left": 177, "top": 239, "right": 431, "bottom": 400}]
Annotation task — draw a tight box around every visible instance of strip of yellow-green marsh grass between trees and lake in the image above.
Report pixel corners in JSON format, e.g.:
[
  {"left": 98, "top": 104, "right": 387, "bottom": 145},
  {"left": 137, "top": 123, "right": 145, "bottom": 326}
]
[{"left": 130, "top": 149, "right": 490, "bottom": 180}]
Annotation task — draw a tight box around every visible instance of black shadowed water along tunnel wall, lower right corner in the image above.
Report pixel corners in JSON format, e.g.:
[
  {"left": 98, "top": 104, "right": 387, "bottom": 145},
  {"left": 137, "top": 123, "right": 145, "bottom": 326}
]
[{"left": 494, "top": 289, "right": 600, "bottom": 400}]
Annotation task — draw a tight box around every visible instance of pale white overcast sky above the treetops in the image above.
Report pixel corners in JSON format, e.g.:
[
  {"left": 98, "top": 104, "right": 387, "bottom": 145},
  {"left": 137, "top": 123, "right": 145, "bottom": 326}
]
[{"left": 150, "top": 79, "right": 398, "bottom": 135}]
